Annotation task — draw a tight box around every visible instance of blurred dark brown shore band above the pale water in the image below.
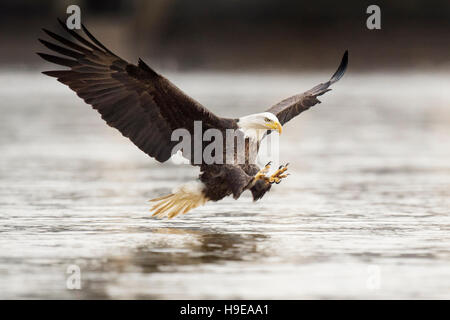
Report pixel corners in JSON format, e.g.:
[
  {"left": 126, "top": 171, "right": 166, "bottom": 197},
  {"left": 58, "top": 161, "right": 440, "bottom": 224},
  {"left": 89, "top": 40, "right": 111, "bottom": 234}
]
[{"left": 0, "top": 0, "right": 450, "bottom": 72}]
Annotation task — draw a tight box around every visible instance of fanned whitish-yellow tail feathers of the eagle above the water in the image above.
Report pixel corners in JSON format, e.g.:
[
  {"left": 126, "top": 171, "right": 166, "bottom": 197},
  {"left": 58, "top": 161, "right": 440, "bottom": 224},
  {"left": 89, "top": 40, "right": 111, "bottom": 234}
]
[{"left": 150, "top": 182, "right": 208, "bottom": 219}]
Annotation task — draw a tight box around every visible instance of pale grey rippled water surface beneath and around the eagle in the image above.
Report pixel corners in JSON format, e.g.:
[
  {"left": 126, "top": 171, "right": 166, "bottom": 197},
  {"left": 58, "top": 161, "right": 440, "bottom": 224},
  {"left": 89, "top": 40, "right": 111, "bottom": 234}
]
[{"left": 0, "top": 71, "right": 450, "bottom": 299}]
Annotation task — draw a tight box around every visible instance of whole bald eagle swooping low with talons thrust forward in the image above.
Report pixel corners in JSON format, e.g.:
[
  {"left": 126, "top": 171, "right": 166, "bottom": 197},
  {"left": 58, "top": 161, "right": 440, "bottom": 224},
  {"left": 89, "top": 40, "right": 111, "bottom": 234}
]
[{"left": 37, "top": 20, "right": 348, "bottom": 218}]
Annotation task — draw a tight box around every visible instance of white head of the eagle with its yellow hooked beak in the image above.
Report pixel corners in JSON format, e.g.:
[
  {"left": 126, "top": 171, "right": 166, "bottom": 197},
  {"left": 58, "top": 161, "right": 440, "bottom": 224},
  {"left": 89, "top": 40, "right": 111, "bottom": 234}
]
[{"left": 238, "top": 112, "right": 282, "bottom": 140}]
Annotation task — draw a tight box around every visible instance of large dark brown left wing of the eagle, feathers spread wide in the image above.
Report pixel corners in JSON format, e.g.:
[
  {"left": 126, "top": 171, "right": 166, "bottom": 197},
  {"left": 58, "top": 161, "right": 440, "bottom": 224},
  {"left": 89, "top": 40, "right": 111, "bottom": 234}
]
[{"left": 38, "top": 20, "right": 234, "bottom": 162}]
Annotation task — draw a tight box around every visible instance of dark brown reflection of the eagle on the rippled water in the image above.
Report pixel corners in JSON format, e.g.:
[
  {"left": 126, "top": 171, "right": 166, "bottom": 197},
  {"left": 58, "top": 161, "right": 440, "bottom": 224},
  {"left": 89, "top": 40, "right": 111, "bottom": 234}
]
[{"left": 67, "top": 228, "right": 266, "bottom": 299}]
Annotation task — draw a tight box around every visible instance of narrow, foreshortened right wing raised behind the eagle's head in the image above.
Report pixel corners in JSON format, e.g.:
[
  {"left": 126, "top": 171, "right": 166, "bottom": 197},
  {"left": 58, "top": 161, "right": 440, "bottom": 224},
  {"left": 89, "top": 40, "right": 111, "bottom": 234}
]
[{"left": 267, "top": 51, "right": 348, "bottom": 125}]
